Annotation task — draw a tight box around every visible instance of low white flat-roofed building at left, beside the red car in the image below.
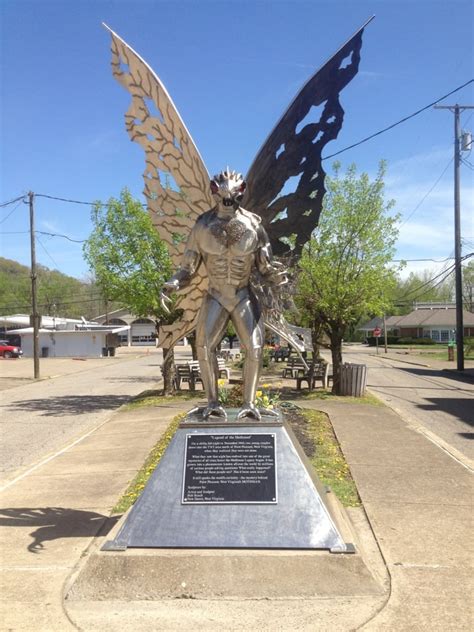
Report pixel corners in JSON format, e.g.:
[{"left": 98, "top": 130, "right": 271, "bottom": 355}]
[{"left": 0, "top": 314, "right": 130, "bottom": 358}]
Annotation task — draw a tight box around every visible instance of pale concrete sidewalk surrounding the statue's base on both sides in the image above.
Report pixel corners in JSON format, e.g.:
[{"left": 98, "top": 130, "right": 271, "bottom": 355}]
[{"left": 0, "top": 392, "right": 473, "bottom": 632}]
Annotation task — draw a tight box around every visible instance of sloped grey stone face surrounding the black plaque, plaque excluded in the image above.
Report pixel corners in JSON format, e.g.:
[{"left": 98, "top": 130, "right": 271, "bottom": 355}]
[{"left": 106, "top": 424, "right": 351, "bottom": 552}]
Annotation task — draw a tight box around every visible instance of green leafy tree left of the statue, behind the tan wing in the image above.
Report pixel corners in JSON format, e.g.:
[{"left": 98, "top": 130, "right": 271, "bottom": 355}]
[{"left": 84, "top": 189, "right": 173, "bottom": 393}]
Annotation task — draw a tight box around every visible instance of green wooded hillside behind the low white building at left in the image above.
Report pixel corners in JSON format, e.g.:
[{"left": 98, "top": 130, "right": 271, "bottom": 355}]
[{"left": 0, "top": 257, "right": 105, "bottom": 318}]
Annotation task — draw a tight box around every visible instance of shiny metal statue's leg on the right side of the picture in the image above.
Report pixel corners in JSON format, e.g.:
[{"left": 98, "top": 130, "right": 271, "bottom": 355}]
[{"left": 231, "top": 296, "right": 265, "bottom": 419}]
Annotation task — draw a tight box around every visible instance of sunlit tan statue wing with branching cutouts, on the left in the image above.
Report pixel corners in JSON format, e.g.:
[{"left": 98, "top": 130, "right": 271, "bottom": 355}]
[{"left": 104, "top": 25, "right": 214, "bottom": 347}]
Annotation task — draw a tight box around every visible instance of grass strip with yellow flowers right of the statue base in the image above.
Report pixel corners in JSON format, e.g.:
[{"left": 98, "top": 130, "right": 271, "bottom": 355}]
[{"left": 290, "top": 410, "right": 361, "bottom": 507}]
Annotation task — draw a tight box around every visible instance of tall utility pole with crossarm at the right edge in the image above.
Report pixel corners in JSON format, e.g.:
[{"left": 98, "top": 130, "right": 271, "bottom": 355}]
[{"left": 434, "top": 103, "right": 474, "bottom": 371}]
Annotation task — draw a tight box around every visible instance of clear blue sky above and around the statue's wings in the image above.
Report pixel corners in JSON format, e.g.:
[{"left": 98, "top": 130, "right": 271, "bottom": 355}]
[{"left": 0, "top": 0, "right": 474, "bottom": 278}]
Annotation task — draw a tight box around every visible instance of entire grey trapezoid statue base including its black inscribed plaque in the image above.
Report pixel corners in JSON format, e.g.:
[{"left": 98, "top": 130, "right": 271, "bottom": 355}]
[{"left": 102, "top": 409, "right": 355, "bottom": 553}]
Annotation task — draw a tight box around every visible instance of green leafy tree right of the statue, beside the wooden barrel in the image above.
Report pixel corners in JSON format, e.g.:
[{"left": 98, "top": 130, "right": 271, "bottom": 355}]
[{"left": 296, "top": 162, "right": 398, "bottom": 393}]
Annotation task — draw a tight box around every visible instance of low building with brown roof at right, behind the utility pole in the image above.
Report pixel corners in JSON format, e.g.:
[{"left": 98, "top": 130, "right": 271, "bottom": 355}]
[{"left": 359, "top": 303, "right": 474, "bottom": 343}]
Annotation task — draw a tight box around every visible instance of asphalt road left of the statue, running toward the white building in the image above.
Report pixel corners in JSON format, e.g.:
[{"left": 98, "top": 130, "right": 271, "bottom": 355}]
[{"left": 0, "top": 349, "right": 170, "bottom": 481}]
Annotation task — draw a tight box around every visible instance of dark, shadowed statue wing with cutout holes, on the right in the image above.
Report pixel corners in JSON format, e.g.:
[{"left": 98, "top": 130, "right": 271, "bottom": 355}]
[{"left": 243, "top": 20, "right": 370, "bottom": 258}]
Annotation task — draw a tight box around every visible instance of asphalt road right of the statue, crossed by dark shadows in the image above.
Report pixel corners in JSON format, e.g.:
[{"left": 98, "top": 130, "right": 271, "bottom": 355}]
[{"left": 343, "top": 346, "right": 474, "bottom": 459}]
